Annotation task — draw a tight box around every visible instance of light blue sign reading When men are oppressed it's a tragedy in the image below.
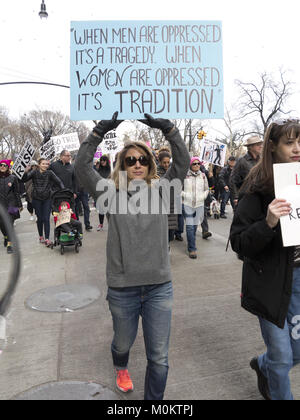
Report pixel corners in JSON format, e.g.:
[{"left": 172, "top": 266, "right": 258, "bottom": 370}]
[{"left": 70, "top": 20, "right": 224, "bottom": 121}]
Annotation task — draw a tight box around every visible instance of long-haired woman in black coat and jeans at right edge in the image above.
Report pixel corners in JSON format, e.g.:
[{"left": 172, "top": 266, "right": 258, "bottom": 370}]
[{"left": 230, "top": 120, "right": 300, "bottom": 400}]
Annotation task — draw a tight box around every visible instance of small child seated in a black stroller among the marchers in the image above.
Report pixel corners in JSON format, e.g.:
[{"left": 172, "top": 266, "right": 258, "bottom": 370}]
[{"left": 52, "top": 190, "right": 82, "bottom": 254}]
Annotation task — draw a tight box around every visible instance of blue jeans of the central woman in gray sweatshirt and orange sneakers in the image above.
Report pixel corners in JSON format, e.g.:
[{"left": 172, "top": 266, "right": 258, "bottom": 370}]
[{"left": 107, "top": 282, "right": 173, "bottom": 400}]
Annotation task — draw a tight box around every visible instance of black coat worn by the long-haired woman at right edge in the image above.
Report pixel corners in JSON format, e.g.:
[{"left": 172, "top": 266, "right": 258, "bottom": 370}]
[{"left": 230, "top": 192, "right": 294, "bottom": 328}]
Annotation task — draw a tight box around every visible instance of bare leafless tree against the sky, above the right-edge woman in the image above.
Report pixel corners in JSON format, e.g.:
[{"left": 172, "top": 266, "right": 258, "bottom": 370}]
[{"left": 236, "top": 69, "right": 293, "bottom": 135}]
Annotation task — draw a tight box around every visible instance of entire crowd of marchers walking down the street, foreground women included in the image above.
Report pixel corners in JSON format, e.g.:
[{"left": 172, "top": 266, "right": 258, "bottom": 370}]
[{"left": 0, "top": 113, "right": 300, "bottom": 400}]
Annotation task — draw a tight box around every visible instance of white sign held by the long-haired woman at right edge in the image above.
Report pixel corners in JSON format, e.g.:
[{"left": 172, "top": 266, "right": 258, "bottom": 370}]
[{"left": 273, "top": 162, "right": 300, "bottom": 246}]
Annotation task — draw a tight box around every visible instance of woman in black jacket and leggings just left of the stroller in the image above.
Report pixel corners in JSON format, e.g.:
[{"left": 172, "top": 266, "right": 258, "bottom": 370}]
[{"left": 22, "top": 158, "right": 64, "bottom": 246}]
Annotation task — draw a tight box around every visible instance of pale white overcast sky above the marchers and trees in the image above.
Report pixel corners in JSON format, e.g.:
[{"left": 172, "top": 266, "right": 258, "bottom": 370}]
[{"left": 0, "top": 0, "right": 300, "bottom": 130}]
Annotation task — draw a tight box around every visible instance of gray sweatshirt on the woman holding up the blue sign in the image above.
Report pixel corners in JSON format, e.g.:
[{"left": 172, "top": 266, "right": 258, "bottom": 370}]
[{"left": 75, "top": 128, "right": 190, "bottom": 287}]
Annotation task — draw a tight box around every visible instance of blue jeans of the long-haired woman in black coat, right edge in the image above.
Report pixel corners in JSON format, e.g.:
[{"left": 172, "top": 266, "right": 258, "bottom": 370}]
[{"left": 258, "top": 267, "right": 300, "bottom": 400}]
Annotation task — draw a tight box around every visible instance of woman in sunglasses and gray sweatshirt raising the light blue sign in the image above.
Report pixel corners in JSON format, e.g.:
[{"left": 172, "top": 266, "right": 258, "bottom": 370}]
[{"left": 75, "top": 112, "right": 190, "bottom": 400}]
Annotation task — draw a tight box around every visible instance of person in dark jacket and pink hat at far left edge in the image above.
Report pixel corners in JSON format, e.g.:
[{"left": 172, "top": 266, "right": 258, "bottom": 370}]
[{"left": 0, "top": 160, "right": 23, "bottom": 254}]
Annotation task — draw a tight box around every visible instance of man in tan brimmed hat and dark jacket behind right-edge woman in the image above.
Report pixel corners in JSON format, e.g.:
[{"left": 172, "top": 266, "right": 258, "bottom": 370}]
[{"left": 230, "top": 136, "right": 263, "bottom": 206}]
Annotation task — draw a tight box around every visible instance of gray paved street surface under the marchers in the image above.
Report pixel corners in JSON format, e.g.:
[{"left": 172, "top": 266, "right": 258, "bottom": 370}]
[{"left": 0, "top": 207, "right": 300, "bottom": 400}]
